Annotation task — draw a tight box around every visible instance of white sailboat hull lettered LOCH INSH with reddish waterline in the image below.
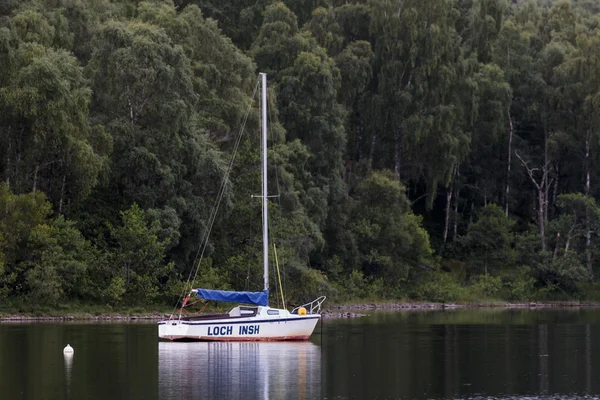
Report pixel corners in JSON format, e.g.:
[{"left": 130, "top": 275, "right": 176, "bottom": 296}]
[{"left": 158, "top": 307, "right": 321, "bottom": 341}]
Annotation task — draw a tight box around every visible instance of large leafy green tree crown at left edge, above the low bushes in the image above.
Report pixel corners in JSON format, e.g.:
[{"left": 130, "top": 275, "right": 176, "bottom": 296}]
[{"left": 0, "top": 34, "right": 103, "bottom": 211}]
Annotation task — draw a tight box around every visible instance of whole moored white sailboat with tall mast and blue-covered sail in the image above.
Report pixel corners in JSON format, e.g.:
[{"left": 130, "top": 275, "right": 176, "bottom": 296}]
[{"left": 158, "top": 73, "right": 325, "bottom": 341}]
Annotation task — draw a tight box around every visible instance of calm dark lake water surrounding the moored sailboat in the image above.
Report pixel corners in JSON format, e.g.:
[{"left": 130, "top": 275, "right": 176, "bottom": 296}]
[{"left": 0, "top": 309, "right": 600, "bottom": 400}]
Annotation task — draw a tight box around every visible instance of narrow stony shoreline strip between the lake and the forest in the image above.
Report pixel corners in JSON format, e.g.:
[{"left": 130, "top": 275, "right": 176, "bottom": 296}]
[{"left": 0, "top": 301, "right": 600, "bottom": 324}]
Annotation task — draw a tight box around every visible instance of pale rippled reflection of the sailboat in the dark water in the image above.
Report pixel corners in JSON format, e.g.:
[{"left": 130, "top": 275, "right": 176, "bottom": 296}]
[{"left": 158, "top": 342, "right": 321, "bottom": 399}]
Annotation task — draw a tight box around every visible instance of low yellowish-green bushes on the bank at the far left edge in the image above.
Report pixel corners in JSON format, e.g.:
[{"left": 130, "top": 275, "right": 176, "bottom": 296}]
[{"left": 0, "top": 186, "right": 101, "bottom": 307}]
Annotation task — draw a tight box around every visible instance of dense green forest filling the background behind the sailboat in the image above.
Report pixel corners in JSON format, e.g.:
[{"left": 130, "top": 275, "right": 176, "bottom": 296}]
[{"left": 0, "top": 0, "right": 600, "bottom": 309}]
